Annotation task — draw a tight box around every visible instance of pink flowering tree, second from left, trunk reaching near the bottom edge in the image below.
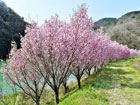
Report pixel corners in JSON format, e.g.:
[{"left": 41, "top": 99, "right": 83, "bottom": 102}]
[{"left": 40, "top": 15, "right": 75, "bottom": 103}]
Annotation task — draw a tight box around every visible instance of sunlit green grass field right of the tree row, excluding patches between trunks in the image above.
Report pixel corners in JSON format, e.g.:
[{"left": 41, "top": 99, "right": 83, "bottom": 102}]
[{"left": 59, "top": 58, "right": 140, "bottom": 105}]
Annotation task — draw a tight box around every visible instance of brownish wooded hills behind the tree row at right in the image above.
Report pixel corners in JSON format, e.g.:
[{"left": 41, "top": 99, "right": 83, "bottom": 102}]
[{"left": 94, "top": 11, "right": 140, "bottom": 49}]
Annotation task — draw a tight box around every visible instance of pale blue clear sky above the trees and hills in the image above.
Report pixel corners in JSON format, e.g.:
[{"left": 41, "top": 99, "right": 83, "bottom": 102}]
[{"left": 3, "top": 0, "right": 140, "bottom": 24}]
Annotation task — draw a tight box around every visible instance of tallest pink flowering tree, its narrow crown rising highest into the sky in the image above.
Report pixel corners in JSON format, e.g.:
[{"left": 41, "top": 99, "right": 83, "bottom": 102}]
[{"left": 70, "top": 7, "right": 93, "bottom": 89}]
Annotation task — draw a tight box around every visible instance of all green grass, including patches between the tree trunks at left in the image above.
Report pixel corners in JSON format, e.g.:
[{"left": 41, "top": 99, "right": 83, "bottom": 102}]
[{"left": 0, "top": 58, "right": 140, "bottom": 105}]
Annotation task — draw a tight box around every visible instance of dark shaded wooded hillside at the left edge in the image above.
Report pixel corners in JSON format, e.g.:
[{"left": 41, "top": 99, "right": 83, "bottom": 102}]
[{"left": 0, "top": 0, "right": 27, "bottom": 59}]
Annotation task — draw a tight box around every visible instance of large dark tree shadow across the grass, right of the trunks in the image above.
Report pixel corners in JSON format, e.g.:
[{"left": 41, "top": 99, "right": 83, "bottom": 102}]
[{"left": 92, "top": 68, "right": 140, "bottom": 90}]
